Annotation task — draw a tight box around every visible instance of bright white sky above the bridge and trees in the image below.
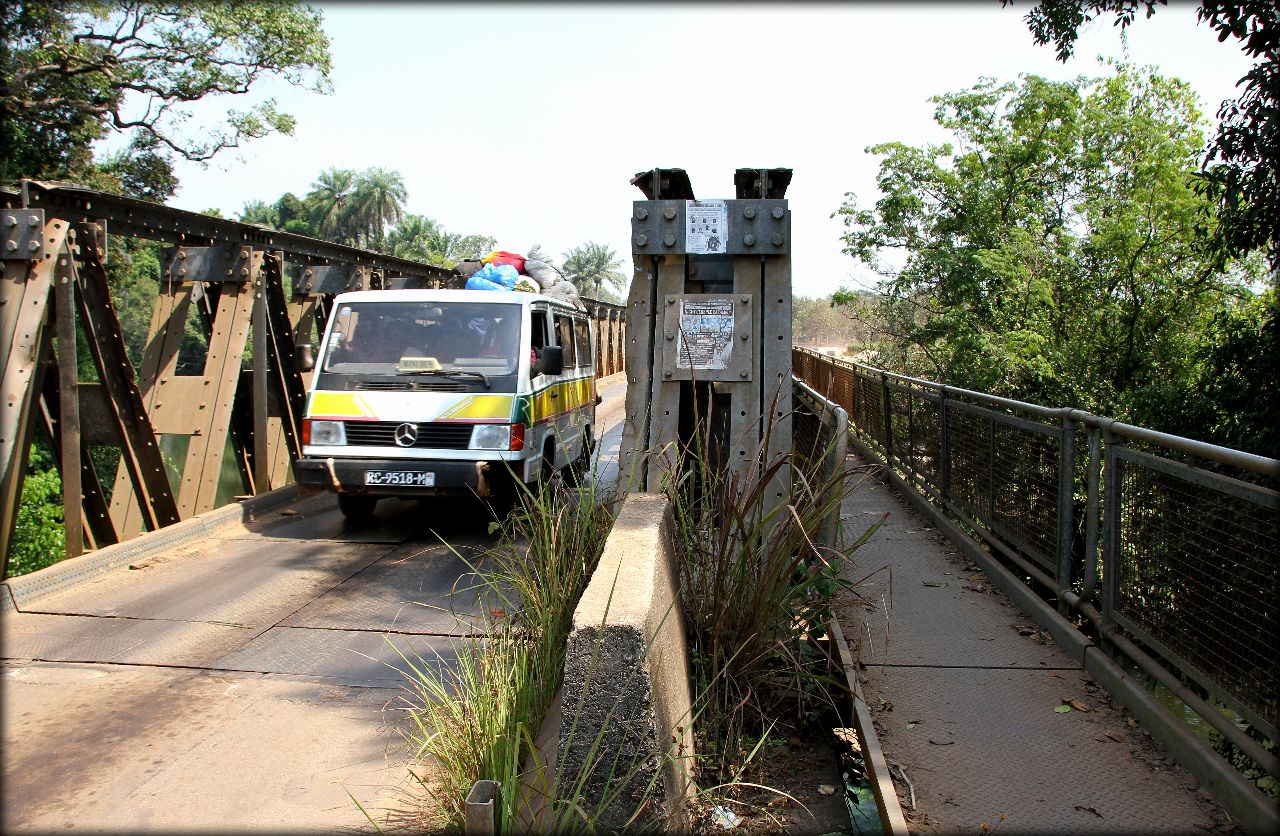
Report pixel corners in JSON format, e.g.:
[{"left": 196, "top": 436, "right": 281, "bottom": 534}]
[{"left": 154, "top": 0, "right": 1249, "bottom": 296}]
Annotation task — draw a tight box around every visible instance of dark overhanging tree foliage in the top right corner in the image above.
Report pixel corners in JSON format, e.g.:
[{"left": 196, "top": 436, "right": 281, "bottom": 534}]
[{"left": 1001, "top": 0, "right": 1280, "bottom": 267}]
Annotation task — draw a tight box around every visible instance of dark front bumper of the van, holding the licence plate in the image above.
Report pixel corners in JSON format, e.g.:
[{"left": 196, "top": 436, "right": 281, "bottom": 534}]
[{"left": 293, "top": 457, "right": 518, "bottom": 497}]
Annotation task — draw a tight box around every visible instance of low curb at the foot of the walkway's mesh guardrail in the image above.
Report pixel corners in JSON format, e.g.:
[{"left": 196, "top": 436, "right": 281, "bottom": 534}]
[{"left": 850, "top": 433, "right": 1280, "bottom": 833}]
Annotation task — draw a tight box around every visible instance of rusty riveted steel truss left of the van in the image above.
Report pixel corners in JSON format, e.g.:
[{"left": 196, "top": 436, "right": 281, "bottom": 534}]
[{"left": 0, "top": 181, "right": 458, "bottom": 575}]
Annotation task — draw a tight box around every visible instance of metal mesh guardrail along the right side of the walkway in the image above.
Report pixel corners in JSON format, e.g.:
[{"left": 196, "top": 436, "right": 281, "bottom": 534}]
[{"left": 792, "top": 348, "right": 1280, "bottom": 793}]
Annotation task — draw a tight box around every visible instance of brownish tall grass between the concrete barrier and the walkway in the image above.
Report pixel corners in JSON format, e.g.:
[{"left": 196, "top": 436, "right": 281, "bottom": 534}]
[{"left": 663, "top": 401, "right": 879, "bottom": 782}]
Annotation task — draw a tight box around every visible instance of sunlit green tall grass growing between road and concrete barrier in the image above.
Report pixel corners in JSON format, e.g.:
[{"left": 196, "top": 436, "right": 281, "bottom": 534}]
[{"left": 389, "top": 466, "right": 613, "bottom": 832}]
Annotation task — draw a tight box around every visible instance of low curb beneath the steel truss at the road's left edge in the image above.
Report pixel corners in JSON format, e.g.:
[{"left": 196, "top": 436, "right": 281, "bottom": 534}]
[{"left": 0, "top": 485, "right": 298, "bottom": 612}]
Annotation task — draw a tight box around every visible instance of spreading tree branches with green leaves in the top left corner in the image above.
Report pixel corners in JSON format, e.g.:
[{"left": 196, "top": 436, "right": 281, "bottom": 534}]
[{"left": 0, "top": 0, "right": 330, "bottom": 181}]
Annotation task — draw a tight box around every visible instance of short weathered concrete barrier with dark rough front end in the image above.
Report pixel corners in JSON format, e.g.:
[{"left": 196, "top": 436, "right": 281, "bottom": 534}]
[{"left": 557, "top": 493, "right": 694, "bottom": 830}]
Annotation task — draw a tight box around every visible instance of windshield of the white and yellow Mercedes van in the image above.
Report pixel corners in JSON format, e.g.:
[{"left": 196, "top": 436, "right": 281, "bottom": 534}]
[{"left": 323, "top": 302, "right": 520, "bottom": 379}]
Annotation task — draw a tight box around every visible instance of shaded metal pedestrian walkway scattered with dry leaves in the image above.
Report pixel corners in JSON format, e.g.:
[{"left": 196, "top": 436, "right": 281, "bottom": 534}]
[{"left": 841, "top": 460, "right": 1228, "bottom": 833}]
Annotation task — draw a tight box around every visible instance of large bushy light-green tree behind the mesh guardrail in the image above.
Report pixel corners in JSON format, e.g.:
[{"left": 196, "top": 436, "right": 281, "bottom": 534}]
[{"left": 837, "top": 65, "right": 1260, "bottom": 417}]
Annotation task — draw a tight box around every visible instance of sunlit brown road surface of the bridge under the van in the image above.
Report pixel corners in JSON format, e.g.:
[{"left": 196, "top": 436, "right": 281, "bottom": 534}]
[{"left": 0, "top": 375, "right": 626, "bottom": 832}]
